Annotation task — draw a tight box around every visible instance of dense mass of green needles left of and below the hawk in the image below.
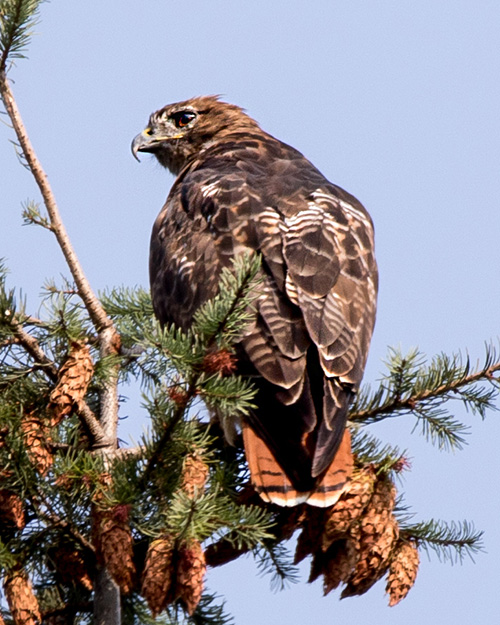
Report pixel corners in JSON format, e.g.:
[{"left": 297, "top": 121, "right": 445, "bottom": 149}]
[{"left": 0, "top": 251, "right": 276, "bottom": 625}]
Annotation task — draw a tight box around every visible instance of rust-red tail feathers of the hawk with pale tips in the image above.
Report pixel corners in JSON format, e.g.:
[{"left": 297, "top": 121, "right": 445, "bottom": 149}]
[{"left": 243, "top": 425, "right": 353, "bottom": 508}]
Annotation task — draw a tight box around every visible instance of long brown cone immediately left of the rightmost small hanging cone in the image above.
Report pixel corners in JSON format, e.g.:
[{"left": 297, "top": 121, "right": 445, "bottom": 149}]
[{"left": 342, "top": 478, "right": 399, "bottom": 598}]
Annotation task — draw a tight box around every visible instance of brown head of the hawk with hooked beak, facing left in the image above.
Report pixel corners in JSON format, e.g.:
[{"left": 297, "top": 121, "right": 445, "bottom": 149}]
[{"left": 132, "top": 96, "right": 259, "bottom": 174}]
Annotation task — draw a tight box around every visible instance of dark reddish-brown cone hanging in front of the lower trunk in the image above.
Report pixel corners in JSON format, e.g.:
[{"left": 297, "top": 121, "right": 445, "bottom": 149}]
[{"left": 93, "top": 505, "right": 136, "bottom": 594}]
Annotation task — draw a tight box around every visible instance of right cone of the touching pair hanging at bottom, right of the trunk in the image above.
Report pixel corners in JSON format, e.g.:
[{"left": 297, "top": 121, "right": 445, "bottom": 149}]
[{"left": 175, "top": 540, "right": 207, "bottom": 616}]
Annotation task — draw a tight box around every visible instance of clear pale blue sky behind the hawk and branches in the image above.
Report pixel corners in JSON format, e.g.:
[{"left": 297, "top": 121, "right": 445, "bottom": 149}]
[{"left": 0, "top": 0, "right": 500, "bottom": 625}]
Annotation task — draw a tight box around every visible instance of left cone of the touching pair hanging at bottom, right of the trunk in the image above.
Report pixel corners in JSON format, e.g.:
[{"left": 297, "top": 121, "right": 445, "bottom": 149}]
[{"left": 141, "top": 537, "right": 174, "bottom": 618}]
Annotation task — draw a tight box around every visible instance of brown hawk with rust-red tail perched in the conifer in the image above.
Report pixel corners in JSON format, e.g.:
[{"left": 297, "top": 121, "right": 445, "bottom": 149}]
[{"left": 132, "top": 96, "right": 377, "bottom": 507}]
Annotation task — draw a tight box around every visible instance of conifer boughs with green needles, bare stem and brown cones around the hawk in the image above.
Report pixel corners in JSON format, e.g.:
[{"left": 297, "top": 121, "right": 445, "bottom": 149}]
[{"left": 0, "top": 0, "right": 500, "bottom": 625}]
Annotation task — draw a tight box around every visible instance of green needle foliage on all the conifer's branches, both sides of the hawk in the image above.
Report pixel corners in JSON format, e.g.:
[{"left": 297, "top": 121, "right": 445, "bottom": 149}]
[{"left": 0, "top": 0, "right": 500, "bottom": 625}]
